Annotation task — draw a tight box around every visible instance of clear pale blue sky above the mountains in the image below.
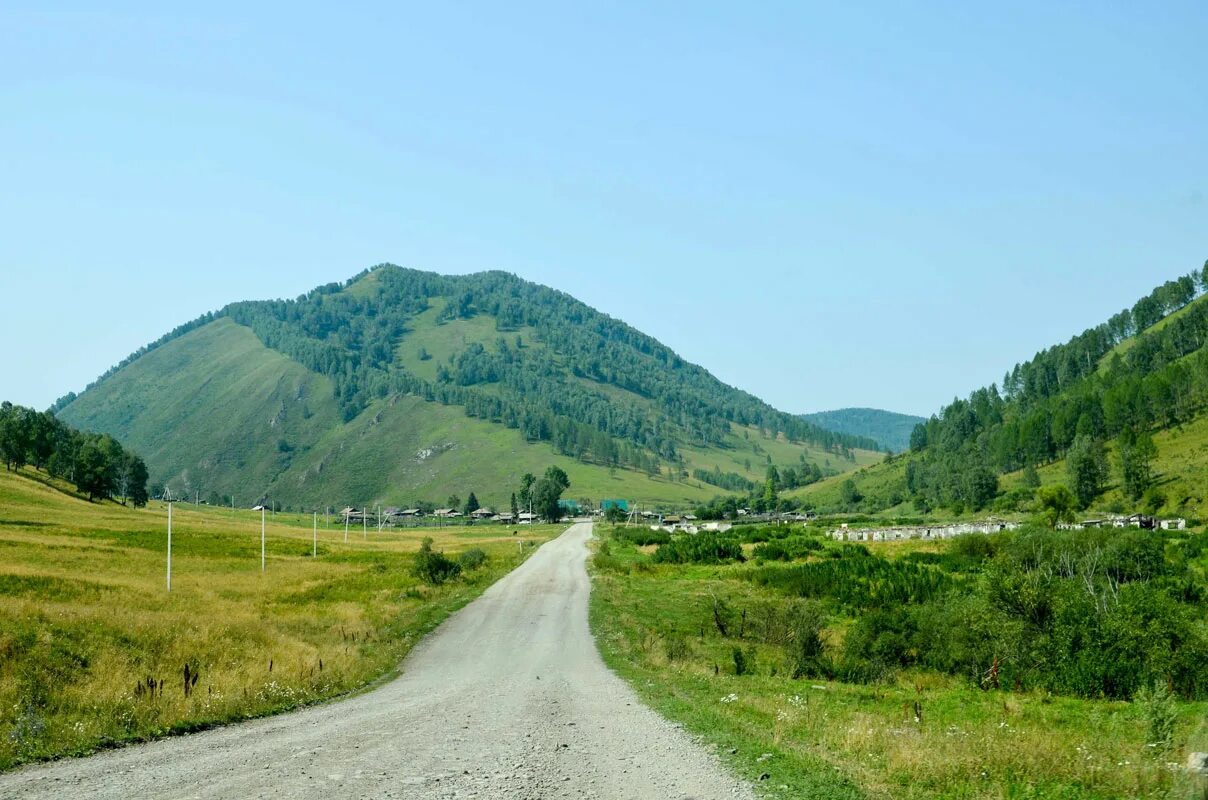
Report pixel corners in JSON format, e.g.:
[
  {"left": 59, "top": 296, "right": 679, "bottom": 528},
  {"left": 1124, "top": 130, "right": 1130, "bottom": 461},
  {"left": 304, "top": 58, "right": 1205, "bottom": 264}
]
[{"left": 0, "top": 0, "right": 1208, "bottom": 413}]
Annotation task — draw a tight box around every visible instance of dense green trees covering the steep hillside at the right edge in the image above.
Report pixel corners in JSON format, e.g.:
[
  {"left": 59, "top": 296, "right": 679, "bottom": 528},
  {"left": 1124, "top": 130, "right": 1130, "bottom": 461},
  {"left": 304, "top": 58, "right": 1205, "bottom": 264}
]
[{"left": 905, "top": 262, "right": 1208, "bottom": 509}]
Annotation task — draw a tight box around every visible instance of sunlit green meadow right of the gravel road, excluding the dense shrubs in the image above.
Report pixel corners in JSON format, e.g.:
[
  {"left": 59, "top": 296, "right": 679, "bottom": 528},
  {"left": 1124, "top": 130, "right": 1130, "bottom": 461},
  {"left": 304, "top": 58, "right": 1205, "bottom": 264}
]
[{"left": 591, "top": 528, "right": 1208, "bottom": 799}]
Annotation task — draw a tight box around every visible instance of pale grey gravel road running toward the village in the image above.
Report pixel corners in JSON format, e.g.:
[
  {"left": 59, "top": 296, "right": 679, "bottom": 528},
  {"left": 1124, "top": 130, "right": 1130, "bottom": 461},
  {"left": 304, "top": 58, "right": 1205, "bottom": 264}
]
[{"left": 0, "top": 523, "right": 753, "bottom": 800}]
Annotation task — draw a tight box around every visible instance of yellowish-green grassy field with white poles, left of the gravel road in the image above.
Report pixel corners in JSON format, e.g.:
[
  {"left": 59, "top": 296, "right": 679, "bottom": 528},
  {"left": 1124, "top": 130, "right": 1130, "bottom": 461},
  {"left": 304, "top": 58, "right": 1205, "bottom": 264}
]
[{"left": 0, "top": 470, "right": 556, "bottom": 769}]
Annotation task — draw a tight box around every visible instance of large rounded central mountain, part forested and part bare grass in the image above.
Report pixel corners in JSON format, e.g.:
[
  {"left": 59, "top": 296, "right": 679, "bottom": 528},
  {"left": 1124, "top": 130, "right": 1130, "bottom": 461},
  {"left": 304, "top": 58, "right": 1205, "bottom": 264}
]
[{"left": 56, "top": 265, "right": 881, "bottom": 508}]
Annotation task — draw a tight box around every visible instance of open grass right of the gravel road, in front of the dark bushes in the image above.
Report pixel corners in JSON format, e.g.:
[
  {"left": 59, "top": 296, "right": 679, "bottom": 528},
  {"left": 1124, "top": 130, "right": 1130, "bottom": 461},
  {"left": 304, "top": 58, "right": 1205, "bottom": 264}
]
[{"left": 591, "top": 532, "right": 1208, "bottom": 800}]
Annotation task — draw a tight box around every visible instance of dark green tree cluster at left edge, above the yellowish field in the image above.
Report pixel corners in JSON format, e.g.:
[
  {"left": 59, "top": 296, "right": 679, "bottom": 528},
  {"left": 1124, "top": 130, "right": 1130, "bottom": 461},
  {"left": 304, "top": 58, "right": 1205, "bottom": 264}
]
[{"left": 0, "top": 401, "right": 147, "bottom": 508}]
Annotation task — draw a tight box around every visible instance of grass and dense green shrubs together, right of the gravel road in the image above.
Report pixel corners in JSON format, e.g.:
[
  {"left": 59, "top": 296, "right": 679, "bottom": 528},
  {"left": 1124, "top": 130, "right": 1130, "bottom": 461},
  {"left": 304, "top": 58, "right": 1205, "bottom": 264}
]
[{"left": 592, "top": 526, "right": 1208, "bottom": 799}]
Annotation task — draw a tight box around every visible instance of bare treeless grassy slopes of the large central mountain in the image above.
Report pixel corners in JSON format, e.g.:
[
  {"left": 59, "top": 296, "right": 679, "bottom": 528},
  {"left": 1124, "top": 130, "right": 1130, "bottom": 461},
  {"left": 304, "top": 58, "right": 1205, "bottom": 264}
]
[{"left": 62, "top": 309, "right": 881, "bottom": 508}]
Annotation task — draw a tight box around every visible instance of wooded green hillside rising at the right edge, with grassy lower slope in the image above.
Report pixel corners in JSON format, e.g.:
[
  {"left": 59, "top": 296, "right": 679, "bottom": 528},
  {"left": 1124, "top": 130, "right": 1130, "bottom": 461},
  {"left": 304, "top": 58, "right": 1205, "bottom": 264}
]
[{"left": 801, "top": 263, "right": 1208, "bottom": 516}]
